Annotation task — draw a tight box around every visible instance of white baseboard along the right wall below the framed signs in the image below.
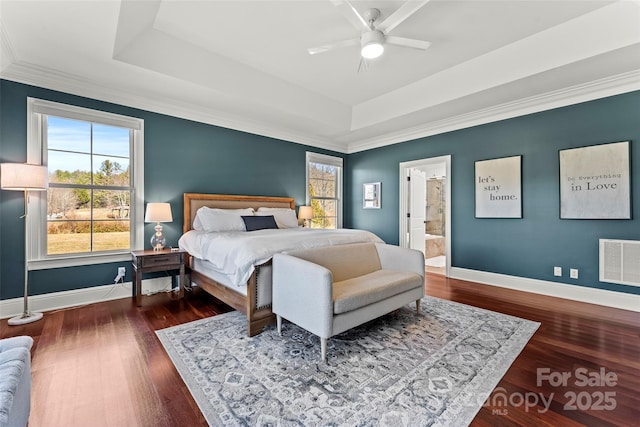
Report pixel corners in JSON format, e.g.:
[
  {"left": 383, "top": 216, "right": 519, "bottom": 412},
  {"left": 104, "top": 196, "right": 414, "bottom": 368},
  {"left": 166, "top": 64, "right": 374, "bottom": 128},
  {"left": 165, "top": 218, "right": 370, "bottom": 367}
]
[{"left": 449, "top": 267, "right": 640, "bottom": 312}]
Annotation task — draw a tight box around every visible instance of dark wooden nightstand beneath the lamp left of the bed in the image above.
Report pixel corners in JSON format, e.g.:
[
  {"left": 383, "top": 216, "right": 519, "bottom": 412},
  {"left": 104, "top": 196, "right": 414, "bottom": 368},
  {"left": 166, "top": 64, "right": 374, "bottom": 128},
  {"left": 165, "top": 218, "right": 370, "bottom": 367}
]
[{"left": 131, "top": 249, "right": 187, "bottom": 307}]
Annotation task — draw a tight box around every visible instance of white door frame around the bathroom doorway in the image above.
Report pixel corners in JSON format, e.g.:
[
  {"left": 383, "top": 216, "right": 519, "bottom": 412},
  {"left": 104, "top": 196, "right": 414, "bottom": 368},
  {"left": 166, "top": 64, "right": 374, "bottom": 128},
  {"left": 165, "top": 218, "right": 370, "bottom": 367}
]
[{"left": 399, "top": 154, "right": 452, "bottom": 277}]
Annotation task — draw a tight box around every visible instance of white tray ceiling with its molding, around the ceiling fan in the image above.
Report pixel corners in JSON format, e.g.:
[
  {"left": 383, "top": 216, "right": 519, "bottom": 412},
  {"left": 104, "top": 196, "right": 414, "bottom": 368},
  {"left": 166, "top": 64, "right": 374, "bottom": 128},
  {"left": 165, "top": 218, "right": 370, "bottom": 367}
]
[{"left": 0, "top": 0, "right": 640, "bottom": 153}]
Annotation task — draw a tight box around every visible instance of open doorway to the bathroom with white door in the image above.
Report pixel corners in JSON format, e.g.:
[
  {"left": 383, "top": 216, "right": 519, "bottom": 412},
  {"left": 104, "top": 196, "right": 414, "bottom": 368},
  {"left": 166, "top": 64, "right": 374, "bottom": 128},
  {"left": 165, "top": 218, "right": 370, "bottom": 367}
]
[{"left": 400, "top": 156, "right": 451, "bottom": 276}]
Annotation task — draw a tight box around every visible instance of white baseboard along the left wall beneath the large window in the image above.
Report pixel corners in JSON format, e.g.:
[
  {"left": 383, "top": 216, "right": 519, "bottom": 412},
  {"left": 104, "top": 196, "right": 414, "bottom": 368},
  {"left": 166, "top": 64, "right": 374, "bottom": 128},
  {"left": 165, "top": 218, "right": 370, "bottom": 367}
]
[{"left": 0, "top": 277, "right": 171, "bottom": 319}]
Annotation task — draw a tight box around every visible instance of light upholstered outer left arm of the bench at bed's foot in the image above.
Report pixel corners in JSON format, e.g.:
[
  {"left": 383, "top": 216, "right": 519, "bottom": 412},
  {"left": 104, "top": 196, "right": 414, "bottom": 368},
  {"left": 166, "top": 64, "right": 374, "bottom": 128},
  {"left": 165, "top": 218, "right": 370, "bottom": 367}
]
[{"left": 272, "top": 254, "right": 333, "bottom": 338}]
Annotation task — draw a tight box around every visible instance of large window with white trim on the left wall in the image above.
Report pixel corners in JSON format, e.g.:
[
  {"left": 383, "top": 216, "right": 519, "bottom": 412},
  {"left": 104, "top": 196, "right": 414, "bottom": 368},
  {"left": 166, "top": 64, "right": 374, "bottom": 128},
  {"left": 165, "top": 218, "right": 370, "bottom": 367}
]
[{"left": 28, "top": 98, "right": 143, "bottom": 269}]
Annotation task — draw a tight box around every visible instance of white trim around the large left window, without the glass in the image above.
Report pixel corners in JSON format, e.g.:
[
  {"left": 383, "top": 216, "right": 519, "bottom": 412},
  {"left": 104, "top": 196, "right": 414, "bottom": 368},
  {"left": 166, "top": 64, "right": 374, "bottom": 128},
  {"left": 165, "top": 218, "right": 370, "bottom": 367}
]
[{"left": 27, "top": 97, "right": 144, "bottom": 270}]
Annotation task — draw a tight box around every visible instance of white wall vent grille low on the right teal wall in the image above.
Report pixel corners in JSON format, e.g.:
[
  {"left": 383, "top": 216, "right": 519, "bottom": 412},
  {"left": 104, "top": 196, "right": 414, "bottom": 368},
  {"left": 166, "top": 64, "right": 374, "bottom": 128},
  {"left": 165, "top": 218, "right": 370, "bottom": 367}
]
[{"left": 600, "top": 239, "right": 640, "bottom": 286}]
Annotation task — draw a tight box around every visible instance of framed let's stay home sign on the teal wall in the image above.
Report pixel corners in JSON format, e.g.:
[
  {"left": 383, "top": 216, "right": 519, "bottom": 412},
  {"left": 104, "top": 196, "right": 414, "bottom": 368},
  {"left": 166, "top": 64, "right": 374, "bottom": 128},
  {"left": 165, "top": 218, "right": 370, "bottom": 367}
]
[{"left": 475, "top": 156, "right": 522, "bottom": 218}]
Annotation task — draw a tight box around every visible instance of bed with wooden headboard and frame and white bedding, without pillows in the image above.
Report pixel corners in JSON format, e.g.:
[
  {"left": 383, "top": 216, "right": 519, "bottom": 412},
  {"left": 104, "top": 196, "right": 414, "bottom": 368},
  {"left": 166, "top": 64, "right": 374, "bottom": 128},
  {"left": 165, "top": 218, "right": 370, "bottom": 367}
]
[{"left": 179, "top": 193, "right": 382, "bottom": 336}]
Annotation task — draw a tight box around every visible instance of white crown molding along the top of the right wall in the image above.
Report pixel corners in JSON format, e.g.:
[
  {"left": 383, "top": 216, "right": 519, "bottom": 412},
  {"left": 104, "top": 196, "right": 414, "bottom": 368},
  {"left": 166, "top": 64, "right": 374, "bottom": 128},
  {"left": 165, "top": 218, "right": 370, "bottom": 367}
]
[{"left": 347, "top": 70, "right": 640, "bottom": 154}]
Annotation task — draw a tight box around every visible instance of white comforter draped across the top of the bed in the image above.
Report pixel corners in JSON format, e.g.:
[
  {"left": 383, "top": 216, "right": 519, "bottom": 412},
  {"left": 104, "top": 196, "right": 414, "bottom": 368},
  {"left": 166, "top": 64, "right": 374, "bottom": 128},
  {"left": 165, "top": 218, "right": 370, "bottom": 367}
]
[{"left": 178, "top": 228, "right": 382, "bottom": 286}]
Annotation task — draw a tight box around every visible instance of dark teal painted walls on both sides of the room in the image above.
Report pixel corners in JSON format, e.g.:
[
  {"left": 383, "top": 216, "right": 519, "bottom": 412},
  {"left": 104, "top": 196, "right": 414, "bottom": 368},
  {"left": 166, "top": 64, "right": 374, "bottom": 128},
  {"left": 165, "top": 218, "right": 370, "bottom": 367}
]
[{"left": 0, "top": 80, "right": 640, "bottom": 299}]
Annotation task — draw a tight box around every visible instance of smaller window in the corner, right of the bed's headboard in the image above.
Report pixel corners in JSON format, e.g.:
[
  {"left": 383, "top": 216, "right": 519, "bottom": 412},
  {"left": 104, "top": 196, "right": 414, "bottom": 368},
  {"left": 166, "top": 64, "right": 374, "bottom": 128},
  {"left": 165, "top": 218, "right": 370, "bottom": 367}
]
[{"left": 307, "top": 152, "right": 342, "bottom": 228}]
